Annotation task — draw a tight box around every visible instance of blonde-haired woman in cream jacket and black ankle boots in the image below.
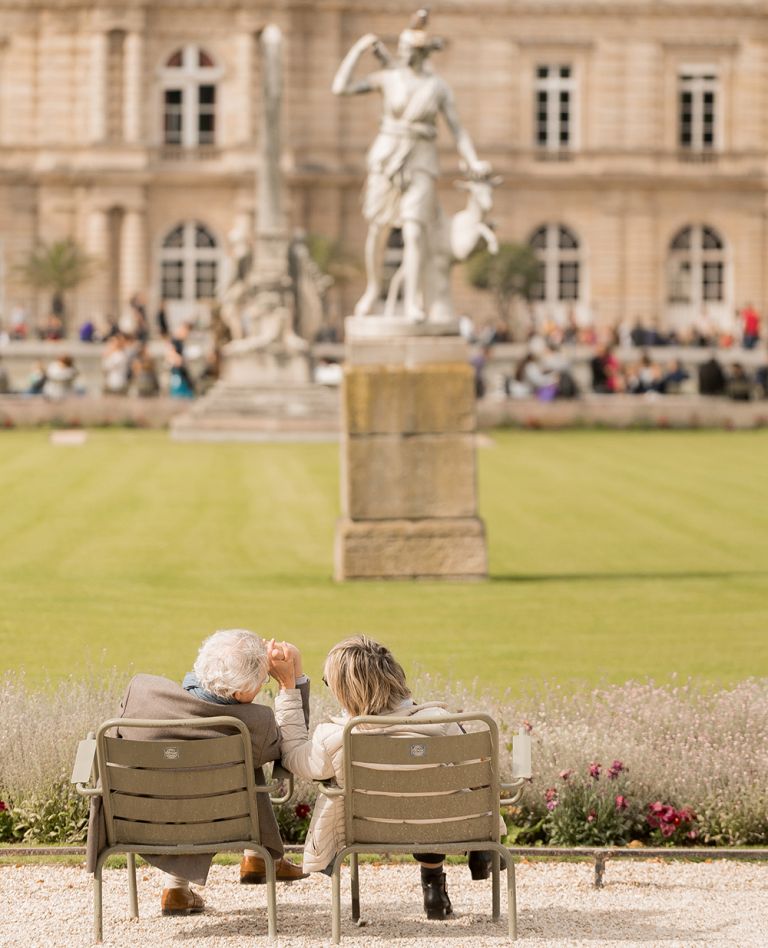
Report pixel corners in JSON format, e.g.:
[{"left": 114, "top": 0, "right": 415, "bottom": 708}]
[{"left": 271, "top": 635, "right": 498, "bottom": 919}]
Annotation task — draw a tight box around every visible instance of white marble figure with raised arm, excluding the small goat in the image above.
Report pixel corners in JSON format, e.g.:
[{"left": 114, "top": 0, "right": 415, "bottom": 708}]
[{"left": 332, "top": 9, "right": 491, "bottom": 323}]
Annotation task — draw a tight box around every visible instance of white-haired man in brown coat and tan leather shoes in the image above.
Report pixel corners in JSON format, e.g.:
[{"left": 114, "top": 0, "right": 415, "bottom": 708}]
[{"left": 88, "top": 629, "right": 309, "bottom": 915}]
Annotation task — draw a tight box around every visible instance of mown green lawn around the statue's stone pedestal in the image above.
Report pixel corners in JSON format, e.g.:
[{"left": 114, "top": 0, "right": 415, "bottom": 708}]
[{"left": 0, "top": 430, "right": 768, "bottom": 690}]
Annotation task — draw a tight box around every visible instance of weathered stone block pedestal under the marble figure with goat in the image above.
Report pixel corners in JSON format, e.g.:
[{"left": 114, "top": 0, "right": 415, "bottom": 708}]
[{"left": 335, "top": 317, "right": 488, "bottom": 580}]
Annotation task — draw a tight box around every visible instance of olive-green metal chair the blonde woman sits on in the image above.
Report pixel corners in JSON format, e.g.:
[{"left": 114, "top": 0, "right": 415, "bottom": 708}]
[{"left": 318, "top": 713, "right": 523, "bottom": 945}]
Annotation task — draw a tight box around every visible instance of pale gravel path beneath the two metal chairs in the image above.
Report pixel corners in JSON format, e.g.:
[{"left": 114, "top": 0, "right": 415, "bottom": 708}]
[{"left": 0, "top": 861, "right": 768, "bottom": 948}]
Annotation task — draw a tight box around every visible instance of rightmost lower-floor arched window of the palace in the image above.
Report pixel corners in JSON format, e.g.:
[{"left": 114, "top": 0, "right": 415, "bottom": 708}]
[{"left": 668, "top": 225, "right": 726, "bottom": 307}]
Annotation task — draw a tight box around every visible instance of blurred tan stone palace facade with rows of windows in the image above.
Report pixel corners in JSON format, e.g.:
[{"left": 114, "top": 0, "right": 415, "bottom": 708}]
[{"left": 0, "top": 0, "right": 768, "bottom": 336}]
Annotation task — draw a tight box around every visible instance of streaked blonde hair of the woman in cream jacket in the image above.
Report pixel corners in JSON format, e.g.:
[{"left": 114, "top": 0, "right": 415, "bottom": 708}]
[{"left": 325, "top": 635, "right": 411, "bottom": 716}]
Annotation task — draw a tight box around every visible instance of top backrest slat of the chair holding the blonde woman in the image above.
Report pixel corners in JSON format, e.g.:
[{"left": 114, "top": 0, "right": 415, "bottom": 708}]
[{"left": 350, "top": 731, "right": 493, "bottom": 765}]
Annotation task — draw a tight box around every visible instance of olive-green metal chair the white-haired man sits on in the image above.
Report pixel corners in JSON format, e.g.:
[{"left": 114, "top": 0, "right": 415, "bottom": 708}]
[{"left": 71, "top": 715, "right": 291, "bottom": 942}]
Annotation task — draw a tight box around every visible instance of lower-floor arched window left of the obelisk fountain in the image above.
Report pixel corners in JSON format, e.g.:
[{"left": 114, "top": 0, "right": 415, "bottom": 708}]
[{"left": 160, "top": 221, "right": 221, "bottom": 303}]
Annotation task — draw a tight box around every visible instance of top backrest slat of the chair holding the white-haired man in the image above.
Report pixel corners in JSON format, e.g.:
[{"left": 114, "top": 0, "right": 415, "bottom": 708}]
[{"left": 104, "top": 734, "right": 243, "bottom": 770}]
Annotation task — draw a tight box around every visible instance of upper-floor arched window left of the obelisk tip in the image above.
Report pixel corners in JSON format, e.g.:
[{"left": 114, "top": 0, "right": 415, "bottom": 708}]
[{"left": 162, "top": 45, "right": 221, "bottom": 148}]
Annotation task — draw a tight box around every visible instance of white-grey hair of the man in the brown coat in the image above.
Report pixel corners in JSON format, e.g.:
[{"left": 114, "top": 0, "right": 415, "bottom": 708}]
[{"left": 194, "top": 629, "right": 267, "bottom": 698}]
